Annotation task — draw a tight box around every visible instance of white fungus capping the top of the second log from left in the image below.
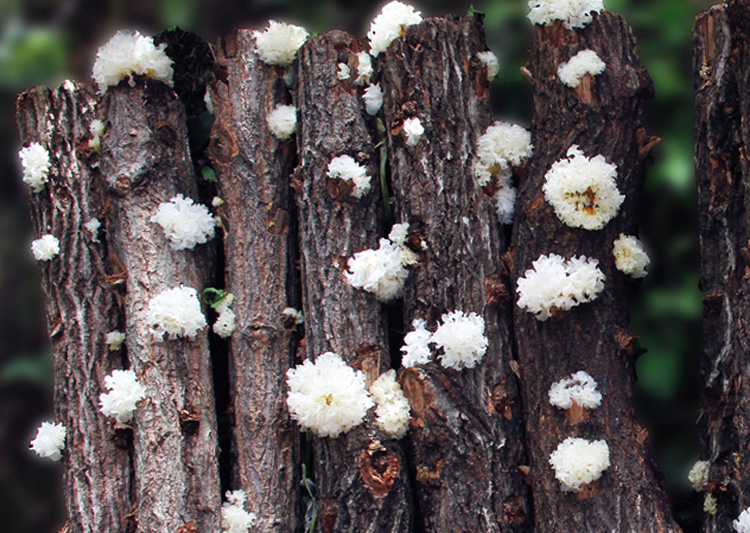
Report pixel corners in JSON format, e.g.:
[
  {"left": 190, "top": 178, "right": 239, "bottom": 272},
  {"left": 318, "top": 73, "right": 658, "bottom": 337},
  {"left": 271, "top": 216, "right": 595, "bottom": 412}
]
[{"left": 91, "top": 31, "right": 173, "bottom": 94}]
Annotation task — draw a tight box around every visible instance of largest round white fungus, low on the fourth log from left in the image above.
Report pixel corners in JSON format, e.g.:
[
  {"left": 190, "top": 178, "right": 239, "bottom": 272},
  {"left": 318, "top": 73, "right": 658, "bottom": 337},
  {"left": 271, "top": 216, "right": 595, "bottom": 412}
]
[{"left": 286, "top": 352, "right": 375, "bottom": 438}]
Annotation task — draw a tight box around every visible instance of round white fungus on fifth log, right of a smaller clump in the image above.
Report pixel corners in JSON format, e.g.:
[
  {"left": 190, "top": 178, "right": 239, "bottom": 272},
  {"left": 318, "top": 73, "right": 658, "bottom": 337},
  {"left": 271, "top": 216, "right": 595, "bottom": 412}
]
[{"left": 431, "top": 311, "right": 489, "bottom": 370}]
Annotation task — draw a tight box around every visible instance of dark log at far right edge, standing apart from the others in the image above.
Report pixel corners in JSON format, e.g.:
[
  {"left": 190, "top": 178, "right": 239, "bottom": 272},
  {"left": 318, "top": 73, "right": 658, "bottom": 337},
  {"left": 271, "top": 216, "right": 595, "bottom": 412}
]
[{"left": 694, "top": 2, "right": 750, "bottom": 532}]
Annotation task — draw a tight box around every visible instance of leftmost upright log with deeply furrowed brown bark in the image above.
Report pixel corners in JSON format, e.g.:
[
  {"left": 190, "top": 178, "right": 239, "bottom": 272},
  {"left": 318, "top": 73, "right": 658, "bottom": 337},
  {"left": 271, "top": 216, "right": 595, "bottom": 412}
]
[{"left": 17, "top": 82, "right": 133, "bottom": 532}]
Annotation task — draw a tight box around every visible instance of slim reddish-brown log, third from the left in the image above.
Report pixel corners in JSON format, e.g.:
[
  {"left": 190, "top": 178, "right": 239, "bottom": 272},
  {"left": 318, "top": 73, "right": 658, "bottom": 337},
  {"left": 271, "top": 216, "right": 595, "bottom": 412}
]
[{"left": 210, "top": 30, "right": 300, "bottom": 531}]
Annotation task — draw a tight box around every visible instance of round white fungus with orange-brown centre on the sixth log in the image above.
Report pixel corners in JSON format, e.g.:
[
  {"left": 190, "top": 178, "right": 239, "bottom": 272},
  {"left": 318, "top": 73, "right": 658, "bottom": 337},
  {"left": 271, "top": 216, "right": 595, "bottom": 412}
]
[{"left": 543, "top": 145, "right": 625, "bottom": 230}]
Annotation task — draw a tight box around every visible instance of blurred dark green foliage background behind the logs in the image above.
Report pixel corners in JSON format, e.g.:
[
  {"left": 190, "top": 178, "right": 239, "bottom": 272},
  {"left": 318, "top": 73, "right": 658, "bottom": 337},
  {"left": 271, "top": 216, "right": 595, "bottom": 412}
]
[{"left": 0, "top": 0, "right": 713, "bottom": 533}]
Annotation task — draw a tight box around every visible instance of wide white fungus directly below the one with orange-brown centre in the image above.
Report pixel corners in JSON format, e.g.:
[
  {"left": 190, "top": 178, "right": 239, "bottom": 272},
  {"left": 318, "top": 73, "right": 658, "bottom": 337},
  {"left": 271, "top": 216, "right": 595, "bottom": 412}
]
[{"left": 516, "top": 254, "right": 606, "bottom": 321}]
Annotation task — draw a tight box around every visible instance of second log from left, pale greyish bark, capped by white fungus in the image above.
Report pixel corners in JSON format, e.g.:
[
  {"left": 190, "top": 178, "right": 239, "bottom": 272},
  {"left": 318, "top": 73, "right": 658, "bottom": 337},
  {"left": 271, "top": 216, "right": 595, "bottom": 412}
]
[{"left": 101, "top": 80, "right": 220, "bottom": 531}]
